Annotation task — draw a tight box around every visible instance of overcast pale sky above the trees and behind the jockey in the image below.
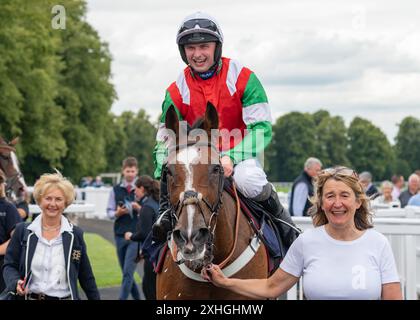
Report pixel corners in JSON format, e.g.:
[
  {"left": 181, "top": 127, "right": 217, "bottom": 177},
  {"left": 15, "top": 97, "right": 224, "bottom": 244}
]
[{"left": 87, "top": 0, "right": 420, "bottom": 143}]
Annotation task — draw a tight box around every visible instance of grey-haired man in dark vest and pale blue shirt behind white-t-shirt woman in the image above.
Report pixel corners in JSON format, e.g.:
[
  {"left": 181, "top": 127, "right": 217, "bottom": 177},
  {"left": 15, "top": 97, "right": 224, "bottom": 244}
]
[{"left": 289, "top": 157, "right": 322, "bottom": 216}]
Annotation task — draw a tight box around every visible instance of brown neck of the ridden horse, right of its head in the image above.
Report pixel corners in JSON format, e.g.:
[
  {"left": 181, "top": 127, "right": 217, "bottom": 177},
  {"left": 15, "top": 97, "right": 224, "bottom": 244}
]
[{"left": 214, "top": 191, "right": 252, "bottom": 263}]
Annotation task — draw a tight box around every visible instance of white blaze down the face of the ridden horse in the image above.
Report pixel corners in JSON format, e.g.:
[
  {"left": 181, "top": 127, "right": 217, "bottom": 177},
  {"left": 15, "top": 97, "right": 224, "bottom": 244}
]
[{"left": 177, "top": 147, "right": 199, "bottom": 239}]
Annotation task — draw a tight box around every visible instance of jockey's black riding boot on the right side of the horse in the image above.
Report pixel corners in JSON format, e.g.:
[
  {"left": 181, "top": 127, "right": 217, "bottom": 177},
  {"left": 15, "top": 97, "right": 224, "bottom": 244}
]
[{"left": 254, "top": 183, "right": 301, "bottom": 251}]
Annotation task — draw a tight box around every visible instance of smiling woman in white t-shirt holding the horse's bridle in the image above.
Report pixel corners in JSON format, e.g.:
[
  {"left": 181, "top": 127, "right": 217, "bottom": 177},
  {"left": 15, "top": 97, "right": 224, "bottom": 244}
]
[{"left": 202, "top": 167, "right": 402, "bottom": 300}]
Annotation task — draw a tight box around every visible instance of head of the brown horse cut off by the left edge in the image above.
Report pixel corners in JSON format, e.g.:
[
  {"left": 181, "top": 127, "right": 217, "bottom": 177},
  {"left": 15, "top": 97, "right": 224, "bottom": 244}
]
[{"left": 0, "top": 137, "right": 27, "bottom": 200}]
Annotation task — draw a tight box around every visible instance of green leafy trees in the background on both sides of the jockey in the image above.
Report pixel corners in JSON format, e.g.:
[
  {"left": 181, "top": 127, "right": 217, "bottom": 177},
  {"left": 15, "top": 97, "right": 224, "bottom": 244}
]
[{"left": 0, "top": 0, "right": 420, "bottom": 183}]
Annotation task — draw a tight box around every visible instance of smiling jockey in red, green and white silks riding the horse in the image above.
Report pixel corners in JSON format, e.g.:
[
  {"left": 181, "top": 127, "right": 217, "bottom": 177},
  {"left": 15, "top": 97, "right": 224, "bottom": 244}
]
[{"left": 153, "top": 12, "right": 294, "bottom": 247}]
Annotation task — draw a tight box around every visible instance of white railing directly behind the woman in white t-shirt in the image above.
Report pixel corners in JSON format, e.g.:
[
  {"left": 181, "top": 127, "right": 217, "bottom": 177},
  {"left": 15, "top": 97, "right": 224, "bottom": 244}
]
[{"left": 287, "top": 215, "right": 420, "bottom": 300}]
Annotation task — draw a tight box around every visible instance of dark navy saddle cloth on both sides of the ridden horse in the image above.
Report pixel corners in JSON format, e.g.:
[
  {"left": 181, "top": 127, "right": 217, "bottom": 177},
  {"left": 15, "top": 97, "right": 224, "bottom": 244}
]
[{"left": 142, "top": 179, "right": 285, "bottom": 275}]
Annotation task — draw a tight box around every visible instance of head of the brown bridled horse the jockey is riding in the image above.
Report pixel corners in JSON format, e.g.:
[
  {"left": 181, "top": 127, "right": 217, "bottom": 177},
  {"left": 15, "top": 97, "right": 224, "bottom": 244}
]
[{"left": 165, "top": 103, "right": 223, "bottom": 268}]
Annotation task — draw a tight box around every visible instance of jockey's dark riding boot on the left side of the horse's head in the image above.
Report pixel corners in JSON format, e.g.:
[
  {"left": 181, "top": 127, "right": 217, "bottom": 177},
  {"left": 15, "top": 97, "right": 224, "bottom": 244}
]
[{"left": 152, "top": 165, "right": 172, "bottom": 243}]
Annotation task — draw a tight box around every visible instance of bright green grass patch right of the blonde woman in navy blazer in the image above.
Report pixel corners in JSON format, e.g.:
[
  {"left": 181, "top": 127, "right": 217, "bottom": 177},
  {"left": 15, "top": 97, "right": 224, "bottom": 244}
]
[{"left": 84, "top": 233, "right": 141, "bottom": 288}]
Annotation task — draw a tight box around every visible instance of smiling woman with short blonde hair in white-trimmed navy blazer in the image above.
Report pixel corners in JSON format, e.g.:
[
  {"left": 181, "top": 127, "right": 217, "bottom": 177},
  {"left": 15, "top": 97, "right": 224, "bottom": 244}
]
[{"left": 3, "top": 173, "right": 99, "bottom": 300}]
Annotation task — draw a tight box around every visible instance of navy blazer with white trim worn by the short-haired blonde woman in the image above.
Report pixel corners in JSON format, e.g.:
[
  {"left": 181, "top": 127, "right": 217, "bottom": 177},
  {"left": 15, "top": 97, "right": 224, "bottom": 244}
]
[{"left": 3, "top": 222, "right": 100, "bottom": 300}]
